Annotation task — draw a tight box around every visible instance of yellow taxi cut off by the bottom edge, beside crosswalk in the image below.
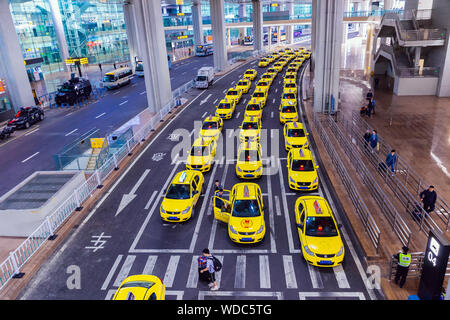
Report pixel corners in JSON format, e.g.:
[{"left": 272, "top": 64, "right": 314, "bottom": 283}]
[{"left": 112, "top": 274, "right": 166, "bottom": 300}]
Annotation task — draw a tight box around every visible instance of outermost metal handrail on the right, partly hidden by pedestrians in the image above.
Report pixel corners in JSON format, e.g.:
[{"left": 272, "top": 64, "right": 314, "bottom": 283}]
[{"left": 352, "top": 112, "right": 450, "bottom": 231}]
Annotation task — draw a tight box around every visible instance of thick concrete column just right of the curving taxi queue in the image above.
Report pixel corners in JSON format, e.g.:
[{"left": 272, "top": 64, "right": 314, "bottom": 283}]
[{"left": 313, "top": 0, "right": 344, "bottom": 112}]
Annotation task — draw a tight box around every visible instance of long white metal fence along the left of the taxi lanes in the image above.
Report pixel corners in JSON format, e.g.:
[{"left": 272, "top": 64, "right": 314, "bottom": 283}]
[{"left": 0, "top": 53, "right": 256, "bottom": 290}]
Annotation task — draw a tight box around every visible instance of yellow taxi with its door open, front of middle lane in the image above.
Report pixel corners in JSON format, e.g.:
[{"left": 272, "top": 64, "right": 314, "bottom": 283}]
[{"left": 214, "top": 183, "right": 266, "bottom": 243}]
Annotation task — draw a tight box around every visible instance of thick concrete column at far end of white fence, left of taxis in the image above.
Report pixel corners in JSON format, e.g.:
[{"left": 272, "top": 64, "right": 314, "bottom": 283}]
[{"left": 128, "top": 0, "right": 172, "bottom": 112}]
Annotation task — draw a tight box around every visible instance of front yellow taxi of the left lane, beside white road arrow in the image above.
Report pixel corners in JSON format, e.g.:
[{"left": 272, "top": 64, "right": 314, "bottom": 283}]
[{"left": 159, "top": 170, "right": 205, "bottom": 222}]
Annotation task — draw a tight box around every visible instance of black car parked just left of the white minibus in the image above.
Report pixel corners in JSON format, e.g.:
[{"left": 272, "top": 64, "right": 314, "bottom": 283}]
[{"left": 55, "top": 78, "right": 92, "bottom": 106}]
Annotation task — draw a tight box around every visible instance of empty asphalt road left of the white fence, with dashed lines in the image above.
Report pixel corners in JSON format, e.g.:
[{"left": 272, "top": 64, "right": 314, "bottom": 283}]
[{"left": 0, "top": 56, "right": 213, "bottom": 196}]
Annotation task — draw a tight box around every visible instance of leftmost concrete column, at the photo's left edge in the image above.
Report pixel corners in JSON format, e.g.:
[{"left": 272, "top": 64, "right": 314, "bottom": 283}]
[{"left": 0, "top": 1, "right": 35, "bottom": 110}]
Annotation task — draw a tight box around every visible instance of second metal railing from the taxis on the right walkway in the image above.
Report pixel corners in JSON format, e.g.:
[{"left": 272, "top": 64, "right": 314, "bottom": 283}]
[{"left": 326, "top": 116, "right": 411, "bottom": 246}]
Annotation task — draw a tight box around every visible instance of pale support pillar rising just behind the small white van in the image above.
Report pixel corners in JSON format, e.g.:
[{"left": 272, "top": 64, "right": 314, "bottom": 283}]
[{"left": 210, "top": 0, "right": 228, "bottom": 71}]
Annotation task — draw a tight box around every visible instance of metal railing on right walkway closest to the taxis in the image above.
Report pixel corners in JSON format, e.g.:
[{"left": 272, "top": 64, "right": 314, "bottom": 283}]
[{"left": 313, "top": 113, "right": 381, "bottom": 253}]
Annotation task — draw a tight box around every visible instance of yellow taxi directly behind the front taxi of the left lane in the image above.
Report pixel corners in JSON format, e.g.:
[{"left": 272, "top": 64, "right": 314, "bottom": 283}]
[{"left": 186, "top": 136, "right": 217, "bottom": 172}]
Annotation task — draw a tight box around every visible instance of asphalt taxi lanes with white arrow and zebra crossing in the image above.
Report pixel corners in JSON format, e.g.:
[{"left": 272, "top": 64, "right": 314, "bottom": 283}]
[{"left": 20, "top": 47, "right": 382, "bottom": 300}]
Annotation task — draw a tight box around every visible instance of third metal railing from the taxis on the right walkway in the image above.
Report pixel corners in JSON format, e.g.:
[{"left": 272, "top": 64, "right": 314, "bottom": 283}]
[{"left": 338, "top": 114, "right": 442, "bottom": 234}]
